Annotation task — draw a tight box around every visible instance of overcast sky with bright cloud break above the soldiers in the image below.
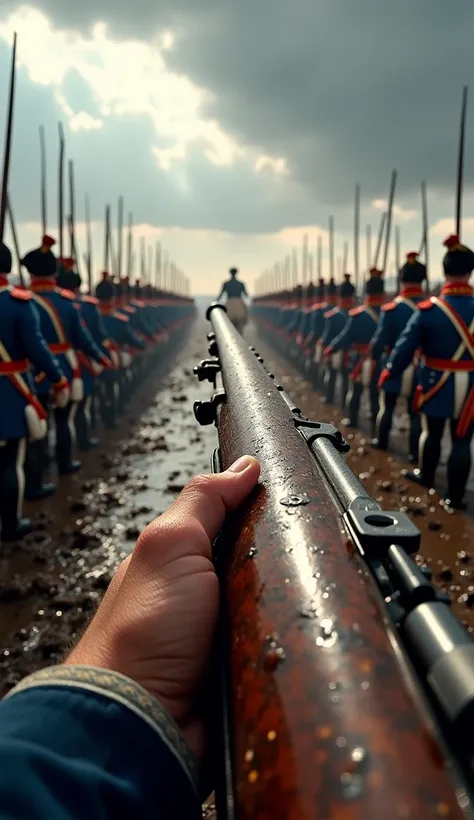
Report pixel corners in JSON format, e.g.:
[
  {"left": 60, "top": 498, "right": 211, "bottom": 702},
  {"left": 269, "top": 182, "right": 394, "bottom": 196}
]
[{"left": 0, "top": 0, "right": 474, "bottom": 293}]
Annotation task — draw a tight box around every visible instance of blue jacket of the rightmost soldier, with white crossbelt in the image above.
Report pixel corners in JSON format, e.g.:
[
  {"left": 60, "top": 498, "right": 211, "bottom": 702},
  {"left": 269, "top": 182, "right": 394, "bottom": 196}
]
[{"left": 384, "top": 283, "right": 474, "bottom": 418}]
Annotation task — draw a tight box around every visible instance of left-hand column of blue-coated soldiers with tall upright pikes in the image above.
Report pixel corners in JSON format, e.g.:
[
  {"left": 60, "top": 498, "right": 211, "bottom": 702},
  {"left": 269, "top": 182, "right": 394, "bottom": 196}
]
[{"left": 0, "top": 35, "right": 194, "bottom": 541}]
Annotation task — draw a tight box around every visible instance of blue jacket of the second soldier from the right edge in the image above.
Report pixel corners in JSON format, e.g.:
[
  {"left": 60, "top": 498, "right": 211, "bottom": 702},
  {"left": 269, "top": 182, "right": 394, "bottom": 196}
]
[{"left": 371, "top": 287, "right": 423, "bottom": 395}]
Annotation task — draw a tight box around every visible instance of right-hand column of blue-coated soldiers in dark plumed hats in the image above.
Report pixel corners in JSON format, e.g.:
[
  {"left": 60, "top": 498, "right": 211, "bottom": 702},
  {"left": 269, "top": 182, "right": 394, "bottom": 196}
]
[{"left": 253, "top": 215, "right": 474, "bottom": 510}]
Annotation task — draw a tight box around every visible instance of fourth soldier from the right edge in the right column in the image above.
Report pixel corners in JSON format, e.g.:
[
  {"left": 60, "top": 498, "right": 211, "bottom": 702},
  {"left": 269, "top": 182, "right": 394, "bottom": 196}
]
[{"left": 321, "top": 273, "right": 355, "bottom": 410}]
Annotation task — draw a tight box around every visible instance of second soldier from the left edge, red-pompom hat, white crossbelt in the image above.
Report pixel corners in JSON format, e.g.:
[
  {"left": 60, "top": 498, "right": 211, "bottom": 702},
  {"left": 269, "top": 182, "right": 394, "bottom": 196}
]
[{"left": 22, "top": 236, "right": 109, "bottom": 498}]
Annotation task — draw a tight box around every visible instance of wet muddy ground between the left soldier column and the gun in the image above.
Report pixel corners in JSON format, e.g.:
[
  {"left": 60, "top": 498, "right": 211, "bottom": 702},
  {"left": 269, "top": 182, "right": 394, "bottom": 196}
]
[{"left": 0, "top": 321, "right": 216, "bottom": 695}]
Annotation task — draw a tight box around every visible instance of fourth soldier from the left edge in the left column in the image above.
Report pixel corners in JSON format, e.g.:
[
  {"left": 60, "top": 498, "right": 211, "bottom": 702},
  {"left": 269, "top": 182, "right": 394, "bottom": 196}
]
[{"left": 95, "top": 278, "right": 145, "bottom": 429}]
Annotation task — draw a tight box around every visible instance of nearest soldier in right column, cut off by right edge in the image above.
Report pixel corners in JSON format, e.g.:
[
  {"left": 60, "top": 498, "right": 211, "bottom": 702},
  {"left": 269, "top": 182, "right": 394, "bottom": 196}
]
[{"left": 380, "top": 236, "right": 474, "bottom": 510}]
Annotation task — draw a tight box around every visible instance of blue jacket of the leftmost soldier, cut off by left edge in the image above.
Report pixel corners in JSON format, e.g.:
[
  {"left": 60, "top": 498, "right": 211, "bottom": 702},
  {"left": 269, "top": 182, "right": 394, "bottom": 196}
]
[{"left": 0, "top": 286, "right": 64, "bottom": 441}]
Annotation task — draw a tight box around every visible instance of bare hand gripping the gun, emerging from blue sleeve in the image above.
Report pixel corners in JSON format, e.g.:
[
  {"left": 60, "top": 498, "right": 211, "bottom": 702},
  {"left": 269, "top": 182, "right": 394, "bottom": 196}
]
[{"left": 66, "top": 456, "right": 260, "bottom": 759}]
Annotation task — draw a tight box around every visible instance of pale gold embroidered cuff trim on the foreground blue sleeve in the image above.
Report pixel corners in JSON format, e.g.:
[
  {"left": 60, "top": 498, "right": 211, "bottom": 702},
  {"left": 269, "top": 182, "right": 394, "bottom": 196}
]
[{"left": 4, "top": 665, "right": 198, "bottom": 791}]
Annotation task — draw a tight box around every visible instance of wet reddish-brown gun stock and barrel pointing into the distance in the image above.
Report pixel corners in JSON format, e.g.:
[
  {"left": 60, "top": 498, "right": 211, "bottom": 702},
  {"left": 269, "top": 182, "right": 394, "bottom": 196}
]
[{"left": 212, "top": 310, "right": 462, "bottom": 820}]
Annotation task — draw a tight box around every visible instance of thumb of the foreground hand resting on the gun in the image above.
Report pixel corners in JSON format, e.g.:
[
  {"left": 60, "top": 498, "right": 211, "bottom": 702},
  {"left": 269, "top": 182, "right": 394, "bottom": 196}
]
[{"left": 158, "top": 456, "right": 260, "bottom": 540}]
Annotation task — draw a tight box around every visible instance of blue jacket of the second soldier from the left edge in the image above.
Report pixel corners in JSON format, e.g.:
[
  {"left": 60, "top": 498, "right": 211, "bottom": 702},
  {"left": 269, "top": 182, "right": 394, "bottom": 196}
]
[{"left": 31, "top": 279, "right": 104, "bottom": 395}]
